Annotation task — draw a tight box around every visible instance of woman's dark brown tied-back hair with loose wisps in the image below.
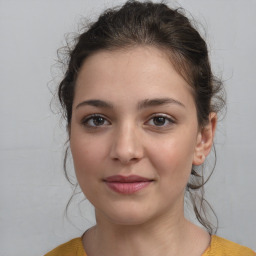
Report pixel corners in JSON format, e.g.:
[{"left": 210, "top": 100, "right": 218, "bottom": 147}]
[{"left": 58, "top": 1, "right": 224, "bottom": 233}]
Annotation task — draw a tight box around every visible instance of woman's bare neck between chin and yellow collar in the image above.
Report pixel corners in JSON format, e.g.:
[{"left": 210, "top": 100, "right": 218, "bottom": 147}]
[{"left": 84, "top": 208, "right": 210, "bottom": 256}]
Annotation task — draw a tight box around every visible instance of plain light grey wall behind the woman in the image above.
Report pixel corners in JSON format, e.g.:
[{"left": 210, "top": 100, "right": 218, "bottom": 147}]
[{"left": 0, "top": 0, "right": 256, "bottom": 256}]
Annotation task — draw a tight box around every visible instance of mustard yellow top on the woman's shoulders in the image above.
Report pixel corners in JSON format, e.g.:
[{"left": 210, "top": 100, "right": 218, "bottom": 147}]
[{"left": 45, "top": 235, "right": 256, "bottom": 256}]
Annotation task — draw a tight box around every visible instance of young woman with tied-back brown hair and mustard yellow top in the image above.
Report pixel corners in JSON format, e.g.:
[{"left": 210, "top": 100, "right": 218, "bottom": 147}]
[{"left": 47, "top": 1, "right": 255, "bottom": 256}]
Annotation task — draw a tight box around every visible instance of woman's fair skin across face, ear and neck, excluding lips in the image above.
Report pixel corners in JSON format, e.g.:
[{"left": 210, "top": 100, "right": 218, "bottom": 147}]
[{"left": 70, "top": 46, "right": 216, "bottom": 256}]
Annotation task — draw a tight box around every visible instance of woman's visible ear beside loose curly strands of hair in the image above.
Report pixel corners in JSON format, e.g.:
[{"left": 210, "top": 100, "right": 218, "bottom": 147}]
[{"left": 193, "top": 112, "right": 217, "bottom": 165}]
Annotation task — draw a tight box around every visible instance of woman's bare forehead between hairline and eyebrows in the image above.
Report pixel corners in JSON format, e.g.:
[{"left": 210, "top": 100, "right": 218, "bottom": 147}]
[{"left": 75, "top": 46, "right": 192, "bottom": 106}]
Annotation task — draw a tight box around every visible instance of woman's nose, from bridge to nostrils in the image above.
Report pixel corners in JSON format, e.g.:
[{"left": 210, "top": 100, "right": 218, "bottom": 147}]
[{"left": 110, "top": 124, "right": 144, "bottom": 164}]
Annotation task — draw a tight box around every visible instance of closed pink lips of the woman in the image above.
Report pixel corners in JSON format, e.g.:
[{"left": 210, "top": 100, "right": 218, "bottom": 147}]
[{"left": 104, "top": 175, "right": 153, "bottom": 194}]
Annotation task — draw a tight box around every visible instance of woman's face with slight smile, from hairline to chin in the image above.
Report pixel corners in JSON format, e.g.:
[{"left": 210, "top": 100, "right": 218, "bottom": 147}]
[{"left": 70, "top": 47, "right": 212, "bottom": 224}]
